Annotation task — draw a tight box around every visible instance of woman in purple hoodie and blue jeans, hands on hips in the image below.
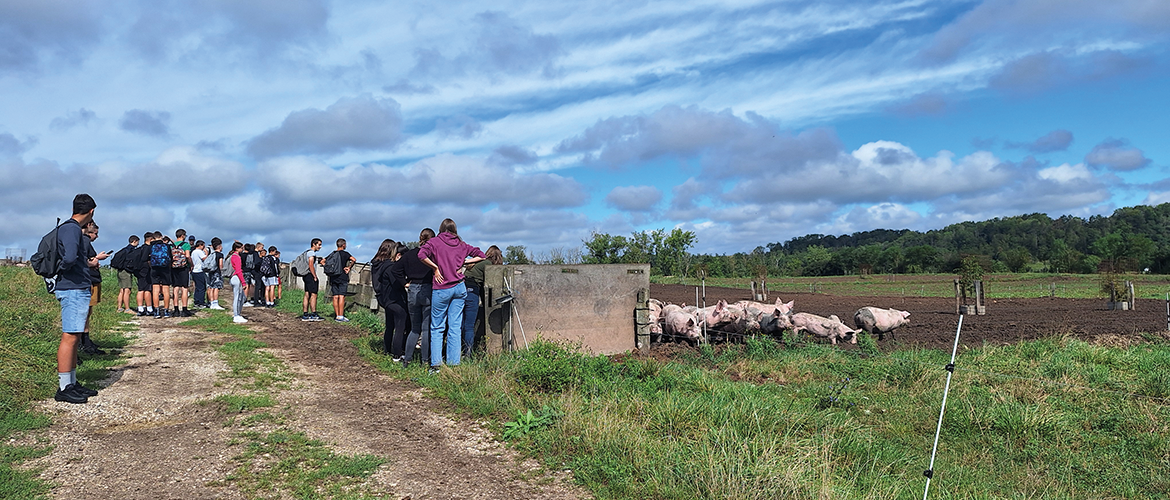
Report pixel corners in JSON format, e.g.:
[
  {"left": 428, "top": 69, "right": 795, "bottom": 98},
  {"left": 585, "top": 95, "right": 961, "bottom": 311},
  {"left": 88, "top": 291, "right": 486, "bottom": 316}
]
[{"left": 419, "top": 219, "right": 487, "bottom": 372}]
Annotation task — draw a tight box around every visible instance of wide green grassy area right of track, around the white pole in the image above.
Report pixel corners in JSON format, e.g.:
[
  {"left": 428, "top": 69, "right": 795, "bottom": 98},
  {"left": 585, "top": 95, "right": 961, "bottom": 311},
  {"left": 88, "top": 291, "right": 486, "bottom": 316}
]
[{"left": 322, "top": 293, "right": 1170, "bottom": 499}]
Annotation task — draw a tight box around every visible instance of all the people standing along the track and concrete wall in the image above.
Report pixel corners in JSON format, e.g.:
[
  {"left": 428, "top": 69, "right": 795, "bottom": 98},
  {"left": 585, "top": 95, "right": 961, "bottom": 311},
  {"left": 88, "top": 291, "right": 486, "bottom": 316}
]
[{"left": 45, "top": 193, "right": 503, "bottom": 403}]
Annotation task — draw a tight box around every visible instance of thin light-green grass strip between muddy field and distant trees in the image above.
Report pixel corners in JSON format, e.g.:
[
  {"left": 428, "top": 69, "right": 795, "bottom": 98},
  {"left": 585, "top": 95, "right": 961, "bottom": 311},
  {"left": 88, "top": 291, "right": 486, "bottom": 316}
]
[{"left": 652, "top": 273, "right": 1170, "bottom": 299}]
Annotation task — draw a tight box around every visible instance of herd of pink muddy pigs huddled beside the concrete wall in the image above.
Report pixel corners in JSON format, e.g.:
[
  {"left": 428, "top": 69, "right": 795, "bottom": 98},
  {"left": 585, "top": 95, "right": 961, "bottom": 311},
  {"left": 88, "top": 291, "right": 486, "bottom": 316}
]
[{"left": 649, "top": 299, "right": 910, "bottom": 344}]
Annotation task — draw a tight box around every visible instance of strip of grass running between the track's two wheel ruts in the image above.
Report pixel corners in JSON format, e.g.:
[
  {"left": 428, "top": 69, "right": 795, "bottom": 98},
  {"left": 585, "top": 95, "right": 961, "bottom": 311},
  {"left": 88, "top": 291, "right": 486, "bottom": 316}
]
[{"left": 181, "top": 303, "right": 385, "bottom": 499}]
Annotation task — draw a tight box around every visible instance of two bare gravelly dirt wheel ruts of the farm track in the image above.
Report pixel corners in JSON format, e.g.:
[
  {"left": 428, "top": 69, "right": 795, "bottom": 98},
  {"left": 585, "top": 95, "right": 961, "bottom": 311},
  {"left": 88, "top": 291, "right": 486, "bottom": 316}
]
[{"left": 29, "top": 308, "right": 587, "bottom": 500}]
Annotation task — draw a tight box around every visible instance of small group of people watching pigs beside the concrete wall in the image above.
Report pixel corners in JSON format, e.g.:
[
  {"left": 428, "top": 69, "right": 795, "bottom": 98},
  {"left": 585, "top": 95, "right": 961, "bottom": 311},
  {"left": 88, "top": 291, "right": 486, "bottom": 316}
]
[{"left": 362, "top": 219, "right": 503, "bottom": 372}]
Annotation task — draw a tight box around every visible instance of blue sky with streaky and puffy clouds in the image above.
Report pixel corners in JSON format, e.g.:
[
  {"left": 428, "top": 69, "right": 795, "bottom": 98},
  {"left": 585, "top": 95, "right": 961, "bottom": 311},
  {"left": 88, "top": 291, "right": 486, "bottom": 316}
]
[{"left": 0, "top": 0, "right": 1170, "bottom": 260}]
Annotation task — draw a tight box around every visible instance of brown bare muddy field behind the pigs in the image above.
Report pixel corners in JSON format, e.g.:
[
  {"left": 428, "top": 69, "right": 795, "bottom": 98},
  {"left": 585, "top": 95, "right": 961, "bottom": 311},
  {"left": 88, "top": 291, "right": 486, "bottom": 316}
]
[{"left": 651, "top": 285, "right": 1166, "bottom": 350}]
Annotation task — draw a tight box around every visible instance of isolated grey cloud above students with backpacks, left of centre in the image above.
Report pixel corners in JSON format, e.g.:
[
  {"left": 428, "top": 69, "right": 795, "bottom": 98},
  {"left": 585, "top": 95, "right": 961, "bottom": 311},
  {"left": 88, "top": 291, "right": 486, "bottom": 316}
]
[{"left": 247, "top": 95, "right": 405, "bottom": 158}]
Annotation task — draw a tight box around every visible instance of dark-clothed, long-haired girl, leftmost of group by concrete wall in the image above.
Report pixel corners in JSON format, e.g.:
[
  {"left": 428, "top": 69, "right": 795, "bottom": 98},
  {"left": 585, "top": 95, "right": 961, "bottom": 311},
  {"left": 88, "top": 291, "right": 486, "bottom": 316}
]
[{"left": 370, "top": 239, "right": 406, "bottom": 363}]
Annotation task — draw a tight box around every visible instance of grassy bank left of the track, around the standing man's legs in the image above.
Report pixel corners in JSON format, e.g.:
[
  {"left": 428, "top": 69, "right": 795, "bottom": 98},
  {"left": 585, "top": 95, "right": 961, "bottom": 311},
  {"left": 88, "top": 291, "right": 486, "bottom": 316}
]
[{"left": 0, "top": 267, "right": 135, "bottom": 499}]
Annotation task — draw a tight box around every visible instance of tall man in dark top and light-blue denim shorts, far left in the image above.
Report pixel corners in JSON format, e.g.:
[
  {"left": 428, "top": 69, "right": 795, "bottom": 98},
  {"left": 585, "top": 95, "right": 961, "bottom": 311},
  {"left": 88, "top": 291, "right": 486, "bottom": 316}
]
[{"left": 53, "top": 193, "right": 98, "bottom": 404}]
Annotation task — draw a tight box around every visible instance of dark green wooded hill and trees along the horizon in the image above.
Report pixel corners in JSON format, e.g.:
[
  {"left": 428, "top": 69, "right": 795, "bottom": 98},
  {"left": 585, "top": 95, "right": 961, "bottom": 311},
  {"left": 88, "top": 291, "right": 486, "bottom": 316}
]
[{"left": 556, "top": 204, "right": 1170, "bottom": 278}]
